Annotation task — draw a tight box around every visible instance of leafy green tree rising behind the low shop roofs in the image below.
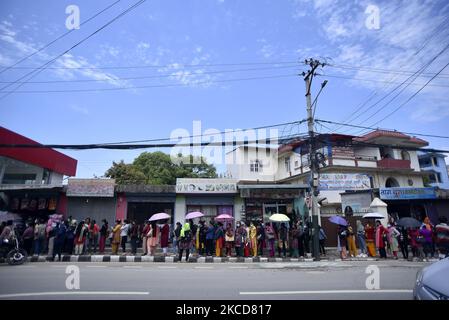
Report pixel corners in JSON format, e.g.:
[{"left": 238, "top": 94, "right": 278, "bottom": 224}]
[{"left": 106, "top": 151, "right": 217, "bottom": 185}]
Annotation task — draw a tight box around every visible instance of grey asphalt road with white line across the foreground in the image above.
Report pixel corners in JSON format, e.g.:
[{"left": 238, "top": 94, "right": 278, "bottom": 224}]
[{"left": 0, "top": 261, "right": 427, "bottom": 300}]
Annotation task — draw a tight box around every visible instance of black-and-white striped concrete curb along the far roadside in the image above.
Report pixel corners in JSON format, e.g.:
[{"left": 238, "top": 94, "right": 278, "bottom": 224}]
[{"left": 28, "top": 255, "right": 438, "bottom": 263}]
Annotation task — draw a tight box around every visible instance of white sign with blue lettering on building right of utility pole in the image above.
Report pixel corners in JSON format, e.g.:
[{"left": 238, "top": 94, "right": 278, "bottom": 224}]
[{"left": 319, "top": 173, "right": 371, "bottom": 190}]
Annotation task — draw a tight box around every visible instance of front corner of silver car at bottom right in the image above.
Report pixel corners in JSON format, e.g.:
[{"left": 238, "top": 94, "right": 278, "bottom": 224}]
[{"left": 413, "top": 258, "right": 449, "bottom": 300}]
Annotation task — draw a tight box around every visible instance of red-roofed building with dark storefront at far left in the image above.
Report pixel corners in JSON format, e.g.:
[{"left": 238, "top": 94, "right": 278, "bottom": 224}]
[{"left": 0, "top": 127, "right": 77, "bottom": 224}]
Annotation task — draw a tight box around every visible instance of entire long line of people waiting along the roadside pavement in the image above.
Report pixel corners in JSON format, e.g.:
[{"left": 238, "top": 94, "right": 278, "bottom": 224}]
[{"left": 0, "top": 217, "right": 449, "bottom": 261}]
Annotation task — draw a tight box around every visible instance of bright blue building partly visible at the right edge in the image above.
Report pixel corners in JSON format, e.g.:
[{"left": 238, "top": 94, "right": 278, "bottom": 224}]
[{"left": 418, "top": 152, "right": 449, "bottom": 189}]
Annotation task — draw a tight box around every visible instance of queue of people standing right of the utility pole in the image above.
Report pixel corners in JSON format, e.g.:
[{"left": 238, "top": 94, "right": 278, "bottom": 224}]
[{"left": 337, "top": 216, "right": 449, "bottom": 260}]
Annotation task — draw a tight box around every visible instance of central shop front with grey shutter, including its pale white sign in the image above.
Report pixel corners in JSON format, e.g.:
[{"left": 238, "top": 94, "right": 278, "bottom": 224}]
[{"left": 176, "top": 179, "right": 241, "bottom": 223}]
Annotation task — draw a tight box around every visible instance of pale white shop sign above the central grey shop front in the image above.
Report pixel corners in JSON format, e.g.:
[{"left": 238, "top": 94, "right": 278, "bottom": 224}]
[{"left": 176, "top": 178, "right": 237, "bottom": 193}]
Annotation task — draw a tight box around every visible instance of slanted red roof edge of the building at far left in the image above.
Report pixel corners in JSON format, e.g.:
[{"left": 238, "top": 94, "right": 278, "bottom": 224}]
[{"left": 0, "top": 127, "right": 77, "bottom": 177}]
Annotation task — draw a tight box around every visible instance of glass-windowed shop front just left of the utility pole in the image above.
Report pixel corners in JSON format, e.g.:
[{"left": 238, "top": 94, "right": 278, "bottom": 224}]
[{"left": 238, "top": 184, "right": 306, "bottom": 223}]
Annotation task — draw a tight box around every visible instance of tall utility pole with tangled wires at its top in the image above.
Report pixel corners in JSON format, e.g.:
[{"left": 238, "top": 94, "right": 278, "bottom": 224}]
[{"left": 302, "top": 59, "right": 324, "bottom": 260}]
